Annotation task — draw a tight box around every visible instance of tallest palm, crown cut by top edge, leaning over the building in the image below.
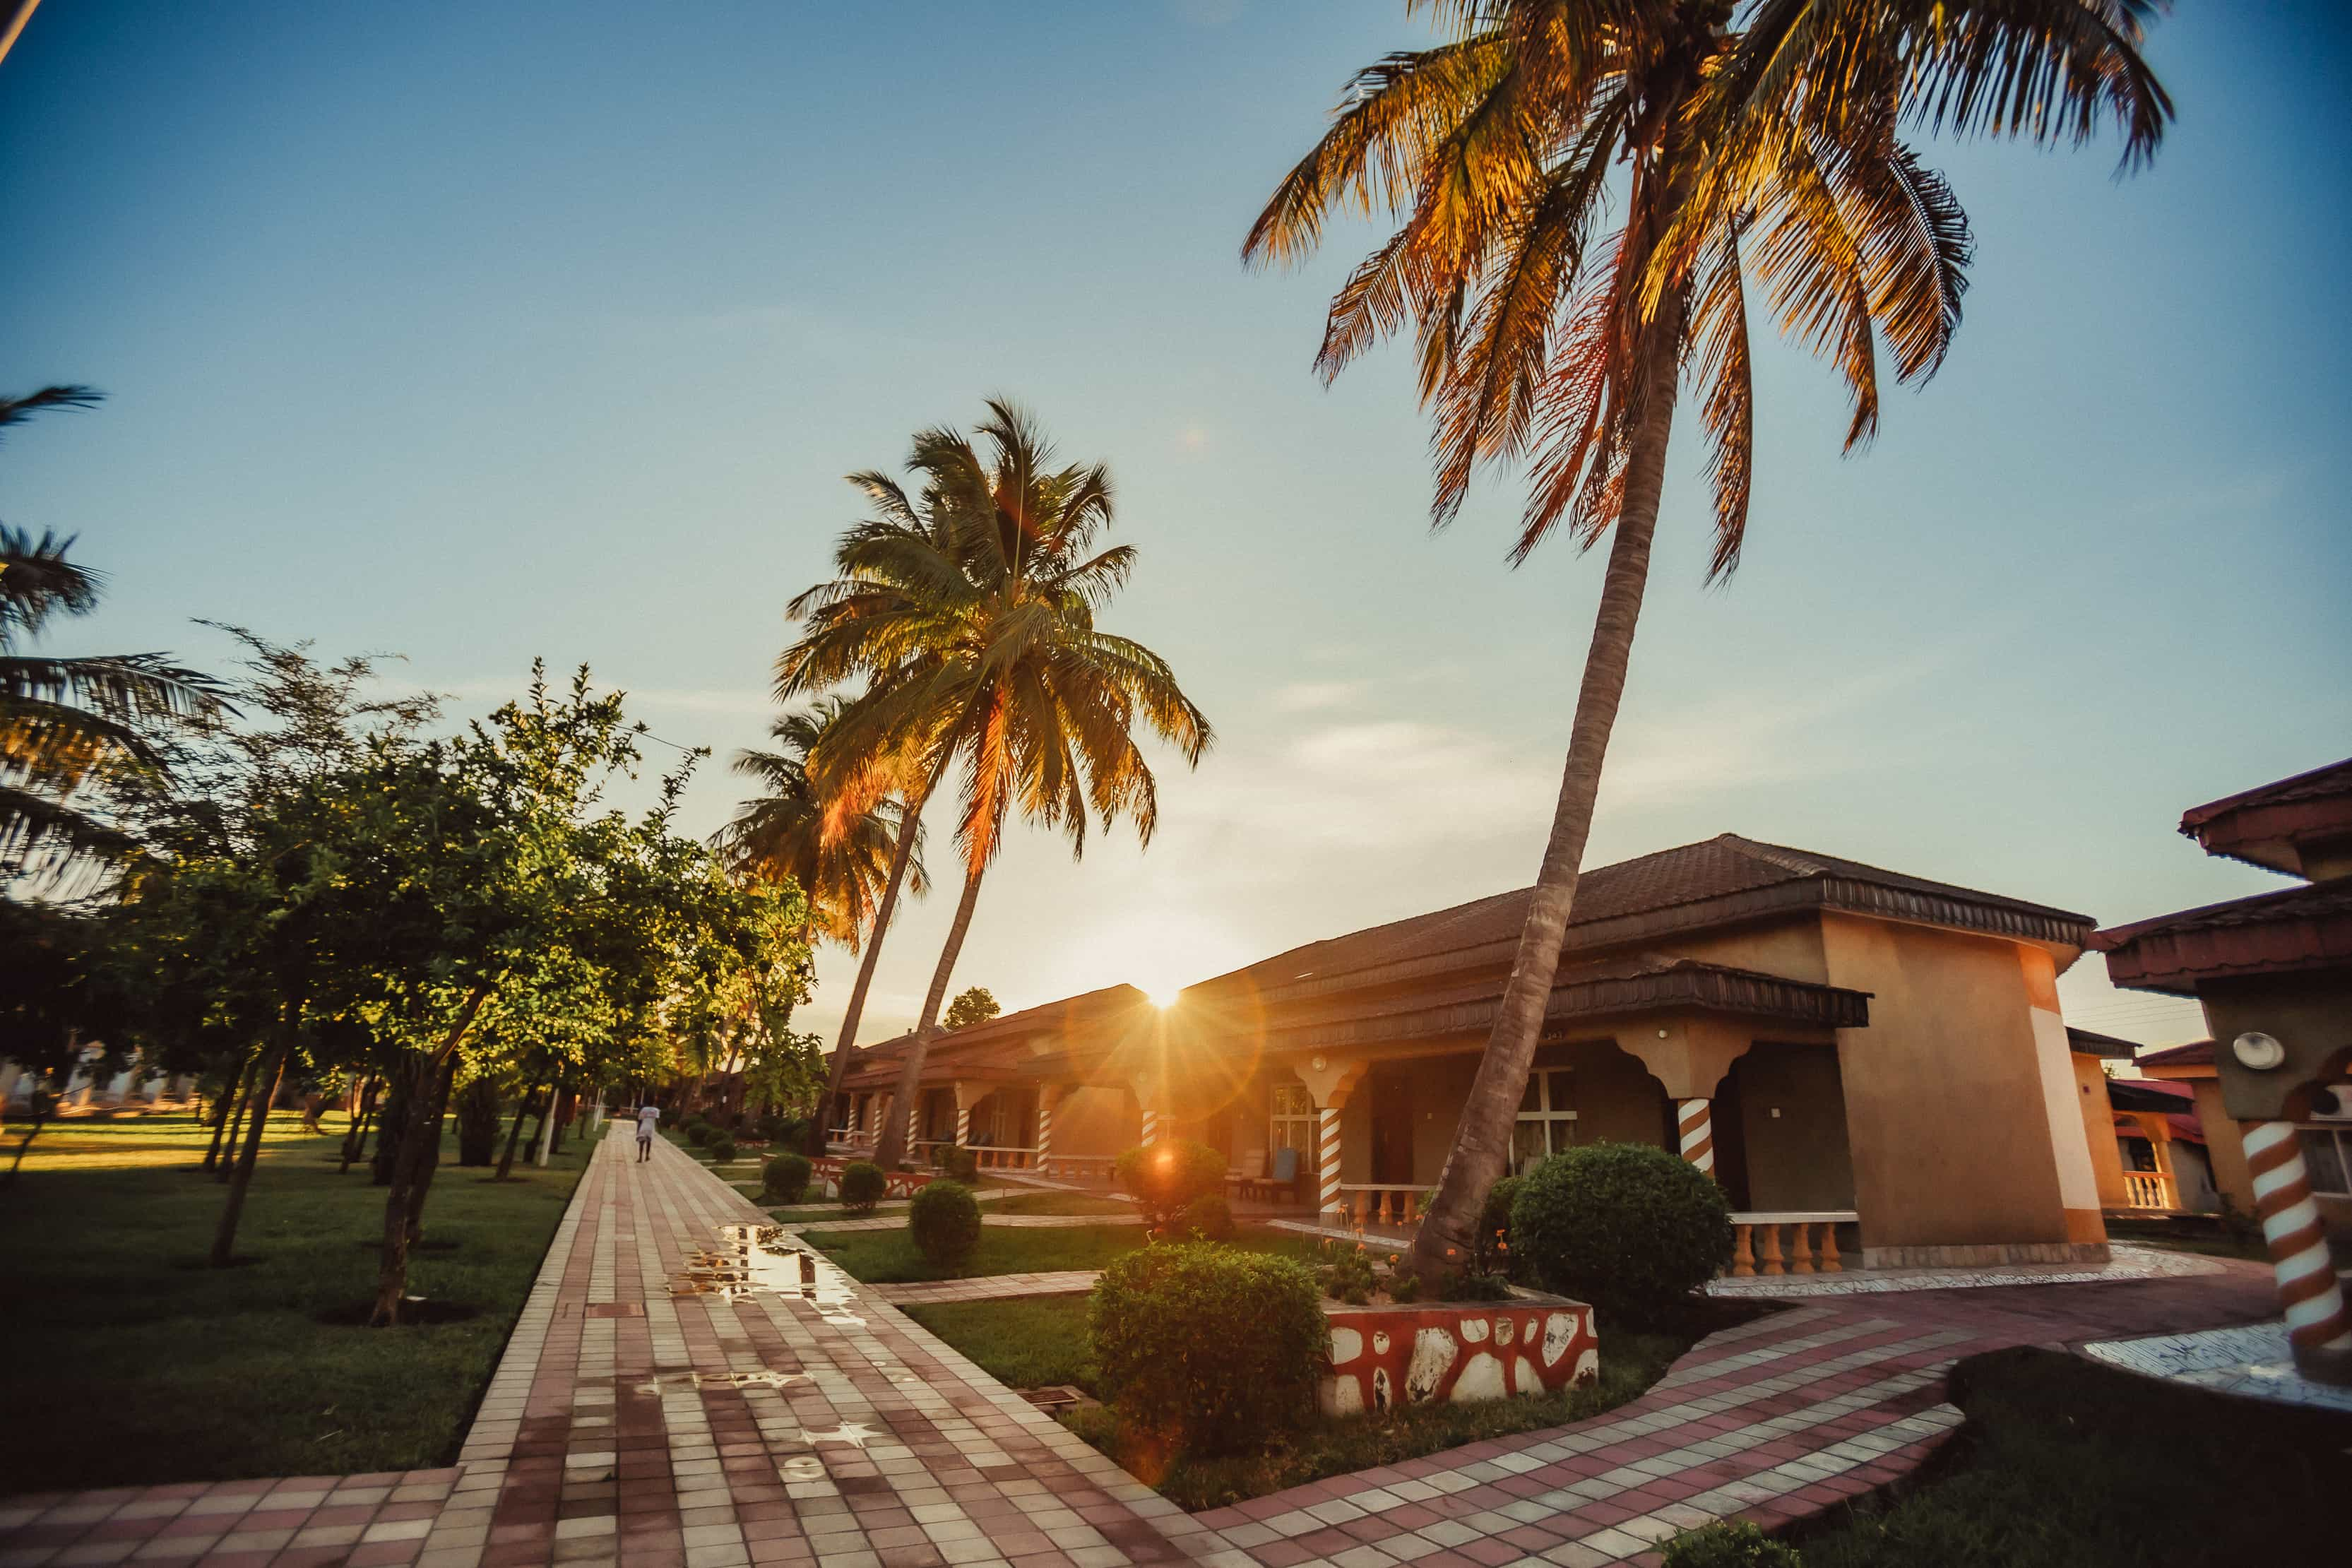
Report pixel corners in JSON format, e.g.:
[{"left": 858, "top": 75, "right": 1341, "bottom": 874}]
[{"left": 1242, "top": 0, "right": 2171, "bottom": 1279}]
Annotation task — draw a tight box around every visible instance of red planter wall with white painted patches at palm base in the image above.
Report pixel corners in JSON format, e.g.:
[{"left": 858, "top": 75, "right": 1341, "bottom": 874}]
[{"left": 1317, "top": 1295, "right": 1602, "bottom": 1415}]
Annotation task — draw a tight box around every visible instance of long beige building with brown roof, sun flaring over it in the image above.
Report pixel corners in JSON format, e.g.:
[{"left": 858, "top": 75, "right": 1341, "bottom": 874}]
[{"left": 840, "top": 835, "right": 2112, "bottom": 1267}]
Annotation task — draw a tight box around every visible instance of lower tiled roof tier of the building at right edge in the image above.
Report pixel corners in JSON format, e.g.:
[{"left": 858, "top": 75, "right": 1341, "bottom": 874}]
[{"left": 2091, "top": 877, "right": 2352, "bottom": 992}]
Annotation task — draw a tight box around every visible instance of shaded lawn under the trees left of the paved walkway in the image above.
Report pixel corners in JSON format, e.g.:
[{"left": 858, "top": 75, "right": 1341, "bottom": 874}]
[{"left": 0, "top": 1112, "right": 588, "bottom": 1490}]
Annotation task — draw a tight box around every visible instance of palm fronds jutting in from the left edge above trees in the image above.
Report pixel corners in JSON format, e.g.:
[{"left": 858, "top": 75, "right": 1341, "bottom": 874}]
[{"left": 0, "top": 386, "right": 221, "bottom": 881}]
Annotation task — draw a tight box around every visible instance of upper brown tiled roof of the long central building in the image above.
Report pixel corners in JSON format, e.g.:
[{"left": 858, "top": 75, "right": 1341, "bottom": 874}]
[{"left": 1202, "top": 832, "right": 2093, "bottom": 990}]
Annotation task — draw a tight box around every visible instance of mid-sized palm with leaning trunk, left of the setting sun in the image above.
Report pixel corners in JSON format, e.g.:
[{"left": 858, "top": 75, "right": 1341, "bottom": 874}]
[{"left": 778, "top": 400, "right": 1211, "bottom": 1166}]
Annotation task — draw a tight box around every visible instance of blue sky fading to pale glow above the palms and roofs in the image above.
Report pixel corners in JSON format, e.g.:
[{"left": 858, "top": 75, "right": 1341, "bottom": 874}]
[{"left": 0, "top": 0, "right": 2352, "bottom": 1044}]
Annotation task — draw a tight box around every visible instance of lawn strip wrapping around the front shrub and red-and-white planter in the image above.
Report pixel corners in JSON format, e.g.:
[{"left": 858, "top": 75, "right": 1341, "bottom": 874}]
[{"left": 905, "top": 1295, "right": 1693, "bottom": 1509}]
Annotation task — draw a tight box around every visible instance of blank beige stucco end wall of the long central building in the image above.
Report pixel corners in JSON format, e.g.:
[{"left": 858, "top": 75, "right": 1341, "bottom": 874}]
[{"left": 1820, "top": 915, "right": 2096, "bottom": 1248}]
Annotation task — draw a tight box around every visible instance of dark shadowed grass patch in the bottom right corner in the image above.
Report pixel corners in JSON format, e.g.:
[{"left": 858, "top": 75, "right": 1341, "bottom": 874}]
[{"left": 1799, "top": 1347, "right": 2352, "bottom": 1568}]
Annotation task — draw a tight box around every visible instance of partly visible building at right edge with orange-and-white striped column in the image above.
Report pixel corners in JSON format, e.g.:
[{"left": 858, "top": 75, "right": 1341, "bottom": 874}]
[{"left": 2096, "top": 759, "right": 2352, "bottom": 1382}]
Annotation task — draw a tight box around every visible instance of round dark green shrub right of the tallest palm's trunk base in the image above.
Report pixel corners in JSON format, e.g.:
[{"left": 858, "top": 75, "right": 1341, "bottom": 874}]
[{"left": 1510, "top": 1143, "right": 1731, "bottom": 1329}]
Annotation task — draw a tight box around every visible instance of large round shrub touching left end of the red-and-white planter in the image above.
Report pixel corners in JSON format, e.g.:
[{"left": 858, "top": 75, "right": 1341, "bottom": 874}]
[{"left": 1089, "top": 1241, "right": 1331, "bottom": 1455}]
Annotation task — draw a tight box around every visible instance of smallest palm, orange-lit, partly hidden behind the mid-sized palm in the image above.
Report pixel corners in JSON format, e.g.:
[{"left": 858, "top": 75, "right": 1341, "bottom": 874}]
[{"left": 718, "top": 696, "right": 932, "bottom": 1147}]
